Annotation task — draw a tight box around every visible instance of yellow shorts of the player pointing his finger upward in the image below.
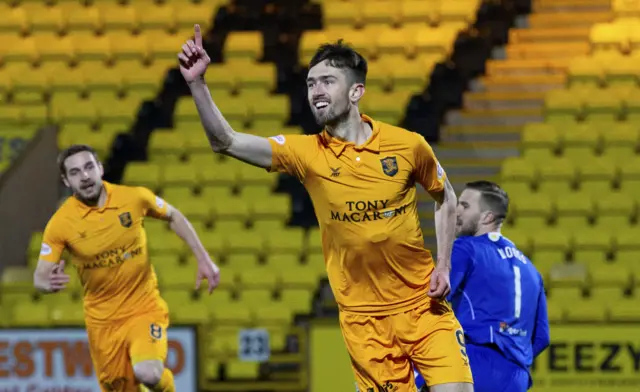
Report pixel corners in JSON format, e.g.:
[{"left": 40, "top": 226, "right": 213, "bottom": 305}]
[{"left": 340, "top": 300, "right": 473, "bottom": 392}]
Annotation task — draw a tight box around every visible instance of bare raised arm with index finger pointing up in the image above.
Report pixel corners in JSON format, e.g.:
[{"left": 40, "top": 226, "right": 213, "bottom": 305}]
[{"left": 178, "top": 25, "right": 273, "bottom": 168}]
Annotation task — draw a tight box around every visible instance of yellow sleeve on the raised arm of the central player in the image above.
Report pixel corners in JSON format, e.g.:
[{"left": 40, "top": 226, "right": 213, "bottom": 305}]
[{"left": 267, "top": 135, "right": 317, "bottom": 182}]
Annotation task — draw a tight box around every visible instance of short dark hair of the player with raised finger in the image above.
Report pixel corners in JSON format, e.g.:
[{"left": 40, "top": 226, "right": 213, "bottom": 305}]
[{"left": 309, "top": 39, "right": 368, "bottom": 84}]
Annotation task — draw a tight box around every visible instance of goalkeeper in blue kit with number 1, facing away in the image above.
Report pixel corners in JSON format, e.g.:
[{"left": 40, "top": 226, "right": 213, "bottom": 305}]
[{"left": 449, "top": 181, "right": 549, "bottom": 392}]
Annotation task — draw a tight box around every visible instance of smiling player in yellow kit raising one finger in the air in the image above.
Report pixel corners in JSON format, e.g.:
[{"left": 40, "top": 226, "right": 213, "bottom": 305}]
[{"left": 178, "top": 26, "right": 473, "bottom": 392}]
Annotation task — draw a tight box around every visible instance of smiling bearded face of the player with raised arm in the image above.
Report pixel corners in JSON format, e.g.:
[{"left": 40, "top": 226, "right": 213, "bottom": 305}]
[{"left": 307, "top": 60, "right": 357, "bottom": 126}]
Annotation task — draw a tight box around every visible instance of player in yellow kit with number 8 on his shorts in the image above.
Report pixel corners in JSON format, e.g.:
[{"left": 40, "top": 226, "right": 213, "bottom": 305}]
[{"left": 34, "top": 145, "right": 220, "bottom": 392}]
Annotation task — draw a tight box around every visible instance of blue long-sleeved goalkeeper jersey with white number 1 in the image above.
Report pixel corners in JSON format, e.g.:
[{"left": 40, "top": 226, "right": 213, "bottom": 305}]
[{"left": 448, "top": 233, "right": 549, "bottom": 370}]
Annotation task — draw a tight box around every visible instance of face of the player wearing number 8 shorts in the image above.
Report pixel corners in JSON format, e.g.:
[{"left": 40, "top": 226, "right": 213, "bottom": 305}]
[{"left": 62, "top": 151, "right": 104, "bottom": 205}]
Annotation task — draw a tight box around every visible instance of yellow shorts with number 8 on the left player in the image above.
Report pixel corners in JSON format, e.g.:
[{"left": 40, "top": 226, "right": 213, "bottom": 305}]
[{"left": 87, "top": 312, "right": 169, "bottom": 392}]
